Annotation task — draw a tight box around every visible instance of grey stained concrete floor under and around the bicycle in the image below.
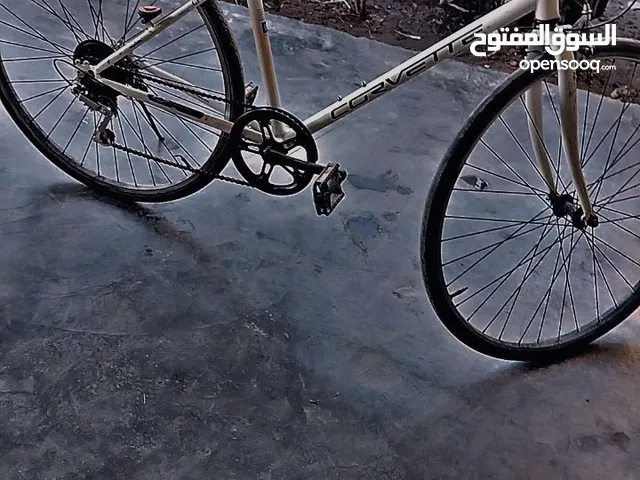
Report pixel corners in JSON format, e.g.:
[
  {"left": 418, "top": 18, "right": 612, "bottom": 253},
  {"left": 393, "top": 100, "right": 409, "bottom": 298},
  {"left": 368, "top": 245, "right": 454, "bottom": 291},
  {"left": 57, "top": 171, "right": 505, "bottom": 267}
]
[{"left": 0, "top": 1, "right": 640, "bottom": 480}]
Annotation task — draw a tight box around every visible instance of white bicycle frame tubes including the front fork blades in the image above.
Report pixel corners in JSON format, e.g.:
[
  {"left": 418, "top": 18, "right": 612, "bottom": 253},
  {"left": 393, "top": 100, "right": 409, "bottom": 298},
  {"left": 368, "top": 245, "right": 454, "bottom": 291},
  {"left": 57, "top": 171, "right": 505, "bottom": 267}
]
[{"left": 86, "top": 0, "right": 593, "bottom": 218}]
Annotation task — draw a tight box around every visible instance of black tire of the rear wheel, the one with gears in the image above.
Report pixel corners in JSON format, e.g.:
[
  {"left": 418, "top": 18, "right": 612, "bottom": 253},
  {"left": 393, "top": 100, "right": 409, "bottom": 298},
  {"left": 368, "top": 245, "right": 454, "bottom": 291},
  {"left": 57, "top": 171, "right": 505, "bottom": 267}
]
[{"left": 0, "top": 0, "right": 245, "bottom": 202}]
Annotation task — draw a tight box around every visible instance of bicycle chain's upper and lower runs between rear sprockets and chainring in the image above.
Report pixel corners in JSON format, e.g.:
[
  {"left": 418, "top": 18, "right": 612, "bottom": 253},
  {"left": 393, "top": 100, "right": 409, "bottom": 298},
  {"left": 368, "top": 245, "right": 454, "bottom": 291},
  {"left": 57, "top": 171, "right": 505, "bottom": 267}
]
[{"left": 106, "top": 66, "right": 258, "bottom": 190}]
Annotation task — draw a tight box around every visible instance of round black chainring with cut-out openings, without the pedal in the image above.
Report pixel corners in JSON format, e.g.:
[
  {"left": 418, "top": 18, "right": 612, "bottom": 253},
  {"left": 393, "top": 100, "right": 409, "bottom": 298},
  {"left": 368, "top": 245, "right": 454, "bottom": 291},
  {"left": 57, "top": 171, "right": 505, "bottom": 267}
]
[{"left": 230, "top": 107, "right": 318, "bottom": 196}]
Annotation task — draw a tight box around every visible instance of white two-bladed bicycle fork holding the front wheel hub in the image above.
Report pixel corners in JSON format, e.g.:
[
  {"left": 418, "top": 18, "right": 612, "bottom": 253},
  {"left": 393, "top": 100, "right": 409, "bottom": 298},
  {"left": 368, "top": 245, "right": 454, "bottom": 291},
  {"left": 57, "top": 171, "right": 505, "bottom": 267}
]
[{"left": 525, "top": 51, "right": 598, "bottom": 228}]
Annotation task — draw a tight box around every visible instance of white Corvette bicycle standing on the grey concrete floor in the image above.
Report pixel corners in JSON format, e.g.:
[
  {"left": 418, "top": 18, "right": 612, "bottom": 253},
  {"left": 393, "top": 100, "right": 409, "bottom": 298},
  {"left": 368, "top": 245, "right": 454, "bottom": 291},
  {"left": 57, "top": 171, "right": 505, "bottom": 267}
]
[{"left": 0, "top": 0, "right": 640, "bottom": 361}]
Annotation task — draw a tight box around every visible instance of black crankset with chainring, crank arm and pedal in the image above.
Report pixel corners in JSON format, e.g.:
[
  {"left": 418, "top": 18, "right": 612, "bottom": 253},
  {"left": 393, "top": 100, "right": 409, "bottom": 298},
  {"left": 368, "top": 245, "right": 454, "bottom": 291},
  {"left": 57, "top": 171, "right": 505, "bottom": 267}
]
[{"left": 230, "top": 107, "right": 347, "bottom": 215}]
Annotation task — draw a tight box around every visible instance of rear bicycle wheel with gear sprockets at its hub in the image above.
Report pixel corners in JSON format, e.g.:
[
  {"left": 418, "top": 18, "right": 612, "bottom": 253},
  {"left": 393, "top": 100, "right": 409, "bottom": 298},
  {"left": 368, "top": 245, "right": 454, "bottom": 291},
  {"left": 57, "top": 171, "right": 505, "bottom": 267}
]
[{"left": 0, "top": 0, "right": 244, "bottom": 202}]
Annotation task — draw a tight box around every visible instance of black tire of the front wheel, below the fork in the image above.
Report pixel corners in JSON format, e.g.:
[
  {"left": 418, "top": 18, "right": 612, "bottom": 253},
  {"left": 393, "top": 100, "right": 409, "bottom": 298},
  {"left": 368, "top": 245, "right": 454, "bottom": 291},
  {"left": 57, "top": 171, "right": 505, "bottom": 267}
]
[{"left": 420, "top": 39, "right": 640, "bottom": 363}]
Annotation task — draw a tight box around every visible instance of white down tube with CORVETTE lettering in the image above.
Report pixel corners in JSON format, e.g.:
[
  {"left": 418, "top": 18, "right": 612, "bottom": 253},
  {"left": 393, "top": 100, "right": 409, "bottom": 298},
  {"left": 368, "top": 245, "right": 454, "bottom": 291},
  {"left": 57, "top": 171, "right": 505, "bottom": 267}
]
[{"left": 304, "top": 0, "right": 536, "bottom": 137}]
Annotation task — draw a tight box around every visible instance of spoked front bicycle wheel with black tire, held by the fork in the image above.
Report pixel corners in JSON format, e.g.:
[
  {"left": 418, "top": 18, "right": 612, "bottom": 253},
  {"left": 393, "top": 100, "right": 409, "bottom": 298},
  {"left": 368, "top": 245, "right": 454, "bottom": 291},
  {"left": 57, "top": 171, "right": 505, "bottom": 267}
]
[{"left": 421, "top": 39, "right": 640, "bottom": 362}]
